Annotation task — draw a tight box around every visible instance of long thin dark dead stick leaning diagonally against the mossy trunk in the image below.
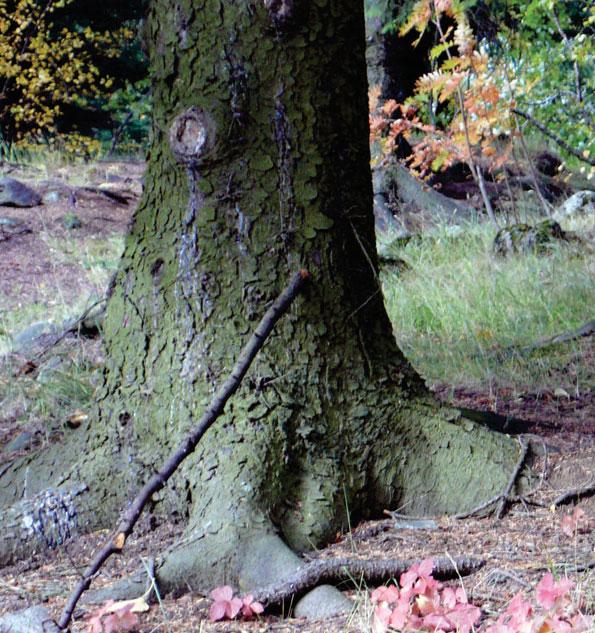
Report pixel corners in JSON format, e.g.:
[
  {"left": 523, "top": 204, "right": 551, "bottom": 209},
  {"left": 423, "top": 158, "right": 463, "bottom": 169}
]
[{"left": 58, "top": 269, "right": 310, "bottom": 629}]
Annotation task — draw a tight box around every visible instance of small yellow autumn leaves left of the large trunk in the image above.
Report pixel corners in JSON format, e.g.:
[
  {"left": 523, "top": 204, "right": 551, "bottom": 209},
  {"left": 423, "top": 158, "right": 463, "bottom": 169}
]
[{"left": 0, "top": 0, "right": 134, "bottom": 152}]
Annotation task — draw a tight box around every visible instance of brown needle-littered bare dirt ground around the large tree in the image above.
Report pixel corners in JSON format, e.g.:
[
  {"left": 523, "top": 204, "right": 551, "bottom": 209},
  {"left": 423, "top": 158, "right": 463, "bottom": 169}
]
[{"left": 0, "top": 164, "right": 595, "bottom": 633}]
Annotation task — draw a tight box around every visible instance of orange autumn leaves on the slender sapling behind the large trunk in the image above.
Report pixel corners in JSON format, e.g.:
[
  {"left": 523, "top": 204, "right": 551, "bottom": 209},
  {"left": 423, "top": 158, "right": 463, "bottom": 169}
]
[{"left": 370, "top": 0, "right": 514, "bottom": 177}]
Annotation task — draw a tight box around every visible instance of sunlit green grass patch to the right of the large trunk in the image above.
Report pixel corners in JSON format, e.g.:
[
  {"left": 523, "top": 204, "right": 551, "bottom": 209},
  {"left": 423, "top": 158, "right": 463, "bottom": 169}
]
[{"left": 382, "top": 224, "right": 595, "bottom": 393}]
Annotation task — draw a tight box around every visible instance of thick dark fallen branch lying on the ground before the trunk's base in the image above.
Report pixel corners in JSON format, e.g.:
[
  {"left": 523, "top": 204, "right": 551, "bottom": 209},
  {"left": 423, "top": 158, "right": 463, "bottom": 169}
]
[{"left": 251, "top": 556, "right": 485, "bottom": 606}]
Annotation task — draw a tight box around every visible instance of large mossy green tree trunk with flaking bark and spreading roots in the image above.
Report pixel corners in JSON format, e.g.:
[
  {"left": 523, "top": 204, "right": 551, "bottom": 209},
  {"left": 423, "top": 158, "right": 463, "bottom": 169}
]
[{"left": 0, "top": 0, "right": 518, "bottom": 608}]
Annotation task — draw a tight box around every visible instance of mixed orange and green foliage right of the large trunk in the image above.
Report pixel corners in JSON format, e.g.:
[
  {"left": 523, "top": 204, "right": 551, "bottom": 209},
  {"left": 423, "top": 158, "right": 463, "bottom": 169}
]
[{"left": 370, "top": 0, "right": 595, "bottom": 176}]
